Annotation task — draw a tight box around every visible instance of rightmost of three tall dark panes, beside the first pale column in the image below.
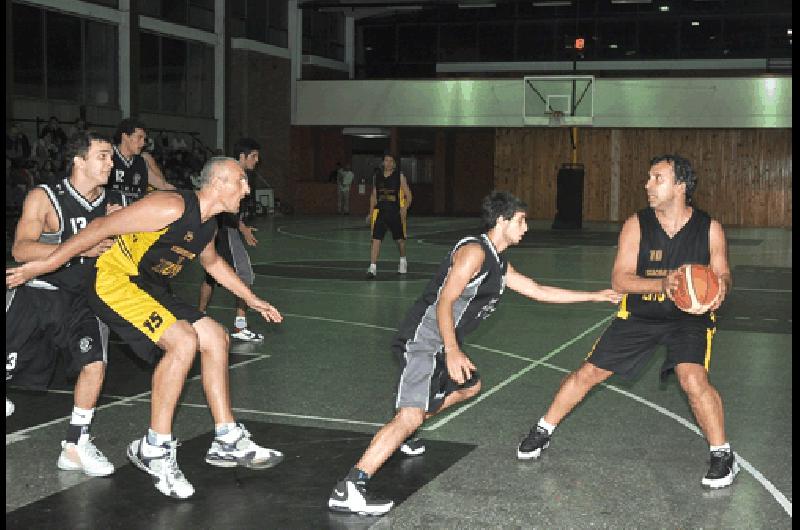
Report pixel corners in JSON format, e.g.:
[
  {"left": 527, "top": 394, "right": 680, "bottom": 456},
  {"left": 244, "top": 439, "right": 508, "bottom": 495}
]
[{"left": 84, "top": 20, "right": 117, "bottom": 105}]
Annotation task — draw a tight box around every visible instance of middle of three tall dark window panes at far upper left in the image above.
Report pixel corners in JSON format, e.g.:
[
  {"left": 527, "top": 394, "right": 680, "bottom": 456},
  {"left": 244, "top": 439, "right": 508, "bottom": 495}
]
[{"left": 45, "top": 11, "right": 82, "bottom": 101}]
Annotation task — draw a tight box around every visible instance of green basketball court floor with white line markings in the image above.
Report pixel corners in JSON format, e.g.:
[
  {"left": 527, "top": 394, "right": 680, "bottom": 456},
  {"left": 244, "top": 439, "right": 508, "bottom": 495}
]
[{"left": 6, "top": 212, "right": 792, "bottom": 529}]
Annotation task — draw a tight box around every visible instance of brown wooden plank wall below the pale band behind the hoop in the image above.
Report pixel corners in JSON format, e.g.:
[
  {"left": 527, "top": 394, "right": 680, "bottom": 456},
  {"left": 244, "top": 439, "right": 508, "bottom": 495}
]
[{"left": 494, "top": 128, "right": 792, "bottom": 227}]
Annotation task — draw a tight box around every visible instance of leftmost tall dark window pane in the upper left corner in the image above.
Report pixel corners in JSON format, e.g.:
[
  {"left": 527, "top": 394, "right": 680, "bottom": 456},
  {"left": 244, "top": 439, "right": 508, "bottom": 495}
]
[{"left": 11, "top": 4, "right": 44, "bottom": 97}]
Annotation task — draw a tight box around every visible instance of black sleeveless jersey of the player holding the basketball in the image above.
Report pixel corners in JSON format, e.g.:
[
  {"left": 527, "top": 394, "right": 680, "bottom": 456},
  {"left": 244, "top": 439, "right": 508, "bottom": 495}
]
[{"left": 620, "top": 208, "right": 711, "bottom": 319}]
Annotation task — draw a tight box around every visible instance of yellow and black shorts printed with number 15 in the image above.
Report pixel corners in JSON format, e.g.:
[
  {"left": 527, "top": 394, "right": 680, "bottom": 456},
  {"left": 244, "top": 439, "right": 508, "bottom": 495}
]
[{"left": 87, "top": 268, "right": 205, "bottom": 364}]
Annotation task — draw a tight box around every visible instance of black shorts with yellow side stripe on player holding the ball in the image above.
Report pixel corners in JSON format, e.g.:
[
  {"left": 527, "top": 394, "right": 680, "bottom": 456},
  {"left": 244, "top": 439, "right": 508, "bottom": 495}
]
[{"left": 586, "top": 315, "right": 716, "bottom": 379}]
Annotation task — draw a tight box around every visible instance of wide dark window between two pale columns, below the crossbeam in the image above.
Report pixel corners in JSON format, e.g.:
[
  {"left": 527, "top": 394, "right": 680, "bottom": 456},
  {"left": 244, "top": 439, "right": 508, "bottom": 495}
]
[{"left": 139, "top": 31, "right": 214, "bottom": 116}]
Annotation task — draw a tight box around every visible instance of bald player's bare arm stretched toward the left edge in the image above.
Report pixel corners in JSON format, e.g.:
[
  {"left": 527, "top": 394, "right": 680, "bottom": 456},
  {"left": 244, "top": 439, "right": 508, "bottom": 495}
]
[{"left": 6, "top": 193, "right": 184, "bottom": 288}]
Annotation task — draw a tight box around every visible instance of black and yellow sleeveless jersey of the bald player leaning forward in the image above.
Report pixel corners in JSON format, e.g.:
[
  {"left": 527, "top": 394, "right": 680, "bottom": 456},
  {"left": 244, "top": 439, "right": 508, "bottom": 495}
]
[{"left": 95, "top": 190, "right": 217, "bottom": 287}]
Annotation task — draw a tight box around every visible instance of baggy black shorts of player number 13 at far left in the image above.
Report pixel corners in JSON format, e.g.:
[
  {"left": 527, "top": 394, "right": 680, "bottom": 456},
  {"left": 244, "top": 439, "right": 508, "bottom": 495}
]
[{"left": 6, "top": 285, "right": 108, "bottom": 389}]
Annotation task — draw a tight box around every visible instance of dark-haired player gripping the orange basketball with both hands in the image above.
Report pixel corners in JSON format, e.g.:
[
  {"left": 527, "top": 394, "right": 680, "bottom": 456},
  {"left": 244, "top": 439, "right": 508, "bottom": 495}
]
[{"left": 517, "top": 155, "right": 739, "bottom": 488}]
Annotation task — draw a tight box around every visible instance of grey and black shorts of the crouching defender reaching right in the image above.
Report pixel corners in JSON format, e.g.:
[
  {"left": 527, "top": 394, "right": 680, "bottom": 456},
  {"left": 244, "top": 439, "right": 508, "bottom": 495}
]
[{"left": 393, "top": 340, "right": 481, "bottom": 413}]
